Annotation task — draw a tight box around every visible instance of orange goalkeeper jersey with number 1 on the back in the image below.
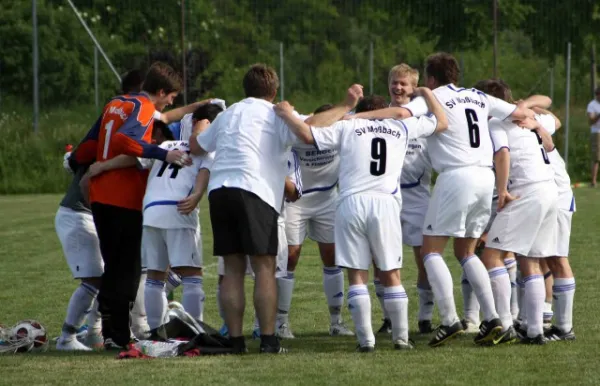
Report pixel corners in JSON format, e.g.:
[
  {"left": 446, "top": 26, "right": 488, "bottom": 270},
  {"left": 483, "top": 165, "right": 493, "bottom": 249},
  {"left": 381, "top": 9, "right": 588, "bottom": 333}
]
[{"left": 90, "top": 94, "right": 156, "bottom": 210}]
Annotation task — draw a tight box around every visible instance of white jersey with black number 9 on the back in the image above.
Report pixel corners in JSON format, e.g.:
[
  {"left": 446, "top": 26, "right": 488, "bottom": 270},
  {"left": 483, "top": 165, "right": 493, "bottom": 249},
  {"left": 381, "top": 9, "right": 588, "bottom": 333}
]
[{"left": 312, "top": 116, "right": 437, "bottom": 202}]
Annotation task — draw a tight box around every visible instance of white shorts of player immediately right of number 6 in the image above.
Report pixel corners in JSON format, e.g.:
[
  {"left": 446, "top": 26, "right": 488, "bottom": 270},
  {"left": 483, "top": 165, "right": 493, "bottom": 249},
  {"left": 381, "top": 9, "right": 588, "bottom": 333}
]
[{"left": 486, "top": 181, "right": 558, "bottom": 258}]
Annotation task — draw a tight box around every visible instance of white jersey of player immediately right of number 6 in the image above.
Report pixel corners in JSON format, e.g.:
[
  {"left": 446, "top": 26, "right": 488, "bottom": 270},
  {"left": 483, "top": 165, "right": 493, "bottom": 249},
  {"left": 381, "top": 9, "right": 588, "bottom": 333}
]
[{"left": 489, "top": 118, "right": 554, "bottom": 189}]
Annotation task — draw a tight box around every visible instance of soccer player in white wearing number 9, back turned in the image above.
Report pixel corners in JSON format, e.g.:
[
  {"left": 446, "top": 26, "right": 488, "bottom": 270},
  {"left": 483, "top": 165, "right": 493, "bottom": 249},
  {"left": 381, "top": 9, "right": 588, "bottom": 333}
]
[{"left": 276, "top": 90, "right": 446, "bottom": 352}]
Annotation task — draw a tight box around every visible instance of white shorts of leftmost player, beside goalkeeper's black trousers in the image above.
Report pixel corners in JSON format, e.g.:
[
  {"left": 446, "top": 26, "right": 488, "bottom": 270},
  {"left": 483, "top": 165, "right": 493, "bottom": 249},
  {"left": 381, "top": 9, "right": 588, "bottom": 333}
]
[{"left": 54, "top": 206, "right": 104, "bottom": 279}]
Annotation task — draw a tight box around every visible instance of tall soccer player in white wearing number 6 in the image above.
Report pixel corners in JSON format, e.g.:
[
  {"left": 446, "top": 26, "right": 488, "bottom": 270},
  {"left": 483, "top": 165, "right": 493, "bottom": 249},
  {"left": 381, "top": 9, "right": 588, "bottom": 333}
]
[{"left": 352, "top": 53, "right": 534, "bottom": 347}]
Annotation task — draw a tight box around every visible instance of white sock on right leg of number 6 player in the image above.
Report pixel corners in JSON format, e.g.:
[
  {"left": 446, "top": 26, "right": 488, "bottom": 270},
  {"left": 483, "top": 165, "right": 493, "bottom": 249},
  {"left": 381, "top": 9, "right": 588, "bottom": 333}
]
[{"left": 460, "top": 255, "right": 500, "bottom": 322}]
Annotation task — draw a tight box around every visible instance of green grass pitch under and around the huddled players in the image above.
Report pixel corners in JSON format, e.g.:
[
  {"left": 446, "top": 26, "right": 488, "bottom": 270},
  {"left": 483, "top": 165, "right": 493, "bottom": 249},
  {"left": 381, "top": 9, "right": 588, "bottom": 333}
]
[{"left": 0, "top": 189, "right": 600, "bottom": 385}]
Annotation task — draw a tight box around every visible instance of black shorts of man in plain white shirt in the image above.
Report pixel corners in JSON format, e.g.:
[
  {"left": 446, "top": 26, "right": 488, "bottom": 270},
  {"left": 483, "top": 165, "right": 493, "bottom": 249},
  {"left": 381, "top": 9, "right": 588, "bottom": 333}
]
[{"left": 208, "top": 187, "right": 279, "bottom": 256}]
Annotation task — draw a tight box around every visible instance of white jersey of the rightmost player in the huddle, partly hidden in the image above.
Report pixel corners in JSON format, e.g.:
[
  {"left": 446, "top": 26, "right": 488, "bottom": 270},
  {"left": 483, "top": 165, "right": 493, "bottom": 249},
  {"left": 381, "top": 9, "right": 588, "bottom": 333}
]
[{"left": 535, "top": 114, "right": 576, "bottom": 212}]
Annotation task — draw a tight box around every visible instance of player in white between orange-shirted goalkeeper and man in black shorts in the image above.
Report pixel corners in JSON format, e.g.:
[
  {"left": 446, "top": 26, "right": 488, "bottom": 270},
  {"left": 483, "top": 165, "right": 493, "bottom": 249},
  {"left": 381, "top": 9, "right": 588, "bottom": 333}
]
[{"left": 142, "top": 104, "right": 223, "bottom": 330}]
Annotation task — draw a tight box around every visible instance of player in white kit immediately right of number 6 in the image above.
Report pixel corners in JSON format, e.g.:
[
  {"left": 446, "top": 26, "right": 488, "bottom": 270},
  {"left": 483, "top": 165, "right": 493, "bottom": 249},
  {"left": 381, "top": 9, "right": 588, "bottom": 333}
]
[{"left": 476, "top": 80, "right": 558, "bottom": 344}]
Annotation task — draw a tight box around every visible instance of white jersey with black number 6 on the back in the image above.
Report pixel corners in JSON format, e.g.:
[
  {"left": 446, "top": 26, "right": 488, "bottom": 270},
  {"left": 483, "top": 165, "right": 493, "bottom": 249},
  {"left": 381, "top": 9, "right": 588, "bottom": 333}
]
[{"left": 427, "top": 84, "right": 516, "bottom": 173}]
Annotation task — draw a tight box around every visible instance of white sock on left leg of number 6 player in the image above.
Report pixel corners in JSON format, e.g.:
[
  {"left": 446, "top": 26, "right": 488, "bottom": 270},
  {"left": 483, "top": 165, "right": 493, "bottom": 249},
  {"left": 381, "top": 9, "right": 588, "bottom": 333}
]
[{"left": 423, "top": 253, "right": 459, "bottom": 326}]
